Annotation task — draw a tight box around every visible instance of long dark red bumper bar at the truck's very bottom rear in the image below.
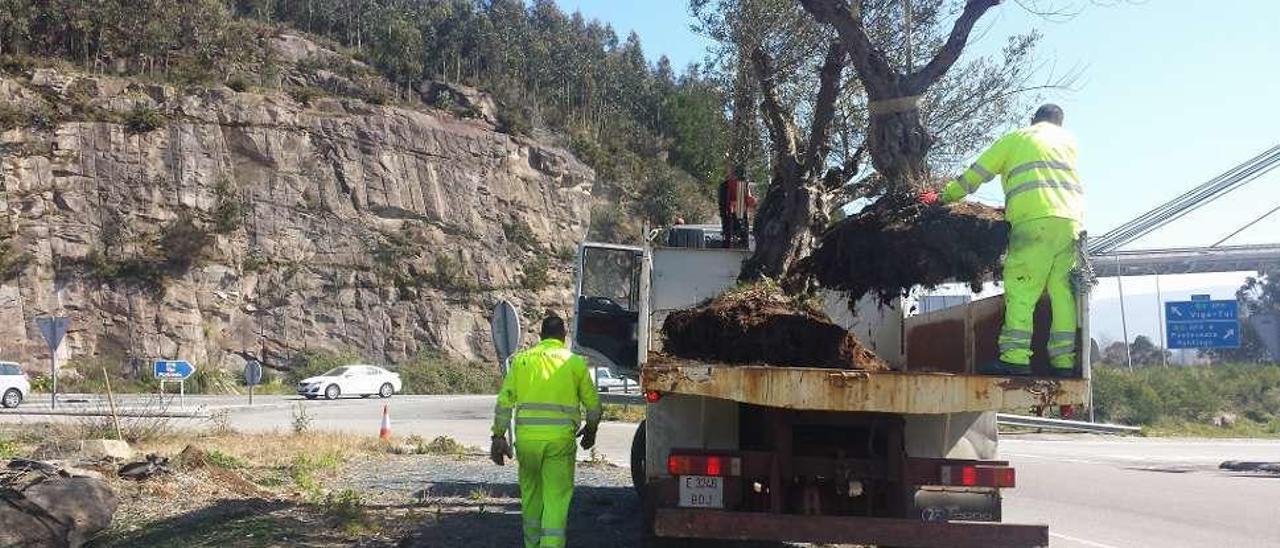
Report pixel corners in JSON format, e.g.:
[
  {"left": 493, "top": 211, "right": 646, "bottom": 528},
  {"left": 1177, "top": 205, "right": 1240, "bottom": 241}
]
[{"left": 653, "top": 508, "right": 1048, "bottom": 548}]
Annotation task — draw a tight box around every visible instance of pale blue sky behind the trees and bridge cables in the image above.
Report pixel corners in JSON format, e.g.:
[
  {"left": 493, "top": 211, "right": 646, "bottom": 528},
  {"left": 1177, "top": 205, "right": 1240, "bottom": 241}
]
[{"left": 559, "top": 0, "right": 1280, "bottom": 340}]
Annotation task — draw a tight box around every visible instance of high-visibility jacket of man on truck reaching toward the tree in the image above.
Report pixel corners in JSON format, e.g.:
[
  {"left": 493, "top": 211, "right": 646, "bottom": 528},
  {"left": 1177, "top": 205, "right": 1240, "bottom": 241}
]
[{"left": 942, "top": 122, "right": 1084, "bottom": 225}]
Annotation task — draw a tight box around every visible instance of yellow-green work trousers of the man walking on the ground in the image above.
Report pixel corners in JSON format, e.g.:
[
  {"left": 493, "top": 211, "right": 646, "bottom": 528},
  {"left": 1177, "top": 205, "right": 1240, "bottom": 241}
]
[{"left": 516, "top": 435, "right": 577, "bottom": 548}]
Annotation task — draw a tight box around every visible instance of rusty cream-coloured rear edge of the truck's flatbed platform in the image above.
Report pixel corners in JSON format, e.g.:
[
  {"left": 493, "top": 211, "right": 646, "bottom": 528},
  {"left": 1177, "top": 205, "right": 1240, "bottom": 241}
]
[{"left": 640, "top": 356, "right": 1088, "bottom": 415}]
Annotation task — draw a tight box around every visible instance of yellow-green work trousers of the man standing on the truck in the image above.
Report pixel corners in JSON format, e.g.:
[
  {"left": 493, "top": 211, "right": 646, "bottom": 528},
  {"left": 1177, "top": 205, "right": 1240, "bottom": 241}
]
[{"left": 1000, "top": 216, "right": 1080, "bottom": 369}]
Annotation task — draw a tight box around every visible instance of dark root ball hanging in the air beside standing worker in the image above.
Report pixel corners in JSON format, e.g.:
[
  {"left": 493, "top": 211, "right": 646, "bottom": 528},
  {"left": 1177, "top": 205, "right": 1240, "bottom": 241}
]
[{"left": 801, "top": 200, "right": 1009, "bottom": 302}]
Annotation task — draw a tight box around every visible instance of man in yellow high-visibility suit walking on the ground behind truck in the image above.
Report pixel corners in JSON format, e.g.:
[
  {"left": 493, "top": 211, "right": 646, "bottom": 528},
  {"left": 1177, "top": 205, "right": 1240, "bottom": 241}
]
[{"left": 489, "top": 315, "right": 600, "bottom": 548}]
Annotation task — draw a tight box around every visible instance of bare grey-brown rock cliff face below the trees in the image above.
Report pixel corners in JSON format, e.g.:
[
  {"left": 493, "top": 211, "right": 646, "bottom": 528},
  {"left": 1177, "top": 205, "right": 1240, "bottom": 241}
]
[{"left": 0, "top": 59, "right": 594, "bottom": 369}]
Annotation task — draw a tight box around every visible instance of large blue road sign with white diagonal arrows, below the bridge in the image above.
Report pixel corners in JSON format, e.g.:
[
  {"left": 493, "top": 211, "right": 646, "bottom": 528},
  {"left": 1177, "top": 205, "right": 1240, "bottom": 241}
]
[{"left": 1165, "top": 294, "right": 1240, "bottom": 350}]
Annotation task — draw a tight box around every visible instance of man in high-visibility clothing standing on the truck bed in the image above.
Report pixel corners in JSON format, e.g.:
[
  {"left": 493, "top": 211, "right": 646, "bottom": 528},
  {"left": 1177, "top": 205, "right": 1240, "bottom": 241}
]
[{"left": 920, "top": 104, "right": 1084, "bottom": 376}]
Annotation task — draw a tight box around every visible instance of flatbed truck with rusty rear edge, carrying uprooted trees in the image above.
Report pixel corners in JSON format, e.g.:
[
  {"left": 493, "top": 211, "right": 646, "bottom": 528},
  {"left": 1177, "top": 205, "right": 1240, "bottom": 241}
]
[{"left": 571, "top": 233, "right": 1089, "bottom": 547}]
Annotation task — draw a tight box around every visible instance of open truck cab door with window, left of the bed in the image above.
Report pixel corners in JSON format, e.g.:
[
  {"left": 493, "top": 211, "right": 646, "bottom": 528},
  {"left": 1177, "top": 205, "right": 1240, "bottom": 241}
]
[{"left": 573, "top": 243, "right": 644, "bottom": 371}]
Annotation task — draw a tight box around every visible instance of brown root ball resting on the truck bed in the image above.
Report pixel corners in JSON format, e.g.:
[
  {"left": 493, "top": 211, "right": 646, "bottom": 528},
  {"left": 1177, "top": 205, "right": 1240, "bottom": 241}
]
[{"left": 662, "top": 282, "right": 888, "bottom": 370}]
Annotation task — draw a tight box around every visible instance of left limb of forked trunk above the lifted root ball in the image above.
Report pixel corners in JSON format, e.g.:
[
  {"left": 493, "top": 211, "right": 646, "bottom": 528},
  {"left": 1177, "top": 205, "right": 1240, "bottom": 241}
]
[{"left": 800, "top": 0, "right": 896, "bottom": 100}]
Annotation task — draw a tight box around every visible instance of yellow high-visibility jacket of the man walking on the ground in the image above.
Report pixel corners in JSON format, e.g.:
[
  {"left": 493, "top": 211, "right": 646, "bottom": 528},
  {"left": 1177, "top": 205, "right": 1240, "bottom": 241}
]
[{"left": 493, "top": 339, "right": 600, "bottom": 440}]
